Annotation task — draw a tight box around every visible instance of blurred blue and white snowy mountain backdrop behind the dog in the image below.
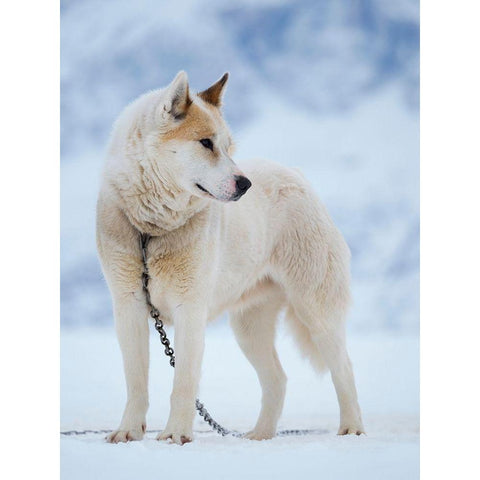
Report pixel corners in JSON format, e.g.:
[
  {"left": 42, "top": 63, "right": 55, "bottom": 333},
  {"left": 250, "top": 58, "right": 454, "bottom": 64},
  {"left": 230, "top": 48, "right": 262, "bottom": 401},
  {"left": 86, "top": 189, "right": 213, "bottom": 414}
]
[{"left": 61, "top": 0, "right": 419, "bottom": 332}]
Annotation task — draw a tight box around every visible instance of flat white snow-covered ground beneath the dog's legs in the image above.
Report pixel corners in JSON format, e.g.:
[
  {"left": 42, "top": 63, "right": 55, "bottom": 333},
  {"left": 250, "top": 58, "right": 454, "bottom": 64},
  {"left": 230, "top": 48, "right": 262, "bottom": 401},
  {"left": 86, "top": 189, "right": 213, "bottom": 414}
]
[{"left": 61, "top": 323, "right": 419, "bottom": 480}]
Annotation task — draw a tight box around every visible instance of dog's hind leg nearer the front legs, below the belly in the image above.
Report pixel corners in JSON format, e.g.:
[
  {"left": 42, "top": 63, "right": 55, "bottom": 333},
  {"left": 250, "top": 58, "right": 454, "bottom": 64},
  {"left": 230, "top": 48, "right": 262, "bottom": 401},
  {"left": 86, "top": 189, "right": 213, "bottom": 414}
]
[{"left": 230, "top": 299, "right": 287, "bottom": 440}]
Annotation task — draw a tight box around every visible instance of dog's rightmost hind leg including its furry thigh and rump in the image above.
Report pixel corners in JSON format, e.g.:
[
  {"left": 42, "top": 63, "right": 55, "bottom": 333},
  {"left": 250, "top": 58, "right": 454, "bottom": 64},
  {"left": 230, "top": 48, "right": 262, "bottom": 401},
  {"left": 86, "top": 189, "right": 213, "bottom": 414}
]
[{"left": 272, "top": 191, "right": 364, "bottom": 434}]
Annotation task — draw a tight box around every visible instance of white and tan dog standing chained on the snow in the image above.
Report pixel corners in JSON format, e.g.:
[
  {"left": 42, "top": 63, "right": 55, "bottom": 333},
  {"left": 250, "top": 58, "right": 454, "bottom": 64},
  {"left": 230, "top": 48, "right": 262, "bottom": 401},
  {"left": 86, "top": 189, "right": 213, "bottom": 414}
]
[{"left": 97, "top": 72, "right": 364, "bottom": 444}]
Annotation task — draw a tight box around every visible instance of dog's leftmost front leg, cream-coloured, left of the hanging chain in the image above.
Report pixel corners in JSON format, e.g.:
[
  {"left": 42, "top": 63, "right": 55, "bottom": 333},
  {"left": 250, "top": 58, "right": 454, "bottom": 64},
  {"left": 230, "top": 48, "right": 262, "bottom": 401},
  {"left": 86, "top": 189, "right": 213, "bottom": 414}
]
[{"left": 107, "top": 294, "right": 149, "bottom": 443}]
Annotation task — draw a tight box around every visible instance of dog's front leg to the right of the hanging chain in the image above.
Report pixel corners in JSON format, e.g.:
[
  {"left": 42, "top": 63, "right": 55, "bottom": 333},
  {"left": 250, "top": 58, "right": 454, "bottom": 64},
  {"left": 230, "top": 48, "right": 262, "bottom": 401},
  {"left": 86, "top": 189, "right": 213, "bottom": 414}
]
[{"left": 157, "top": 305, "right": 206, "bottom": 445}]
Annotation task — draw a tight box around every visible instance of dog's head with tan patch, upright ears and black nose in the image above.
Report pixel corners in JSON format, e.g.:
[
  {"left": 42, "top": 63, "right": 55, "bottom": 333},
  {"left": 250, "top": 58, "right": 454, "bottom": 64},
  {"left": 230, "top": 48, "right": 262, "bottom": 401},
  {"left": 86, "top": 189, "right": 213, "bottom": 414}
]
[{"left": 149, "top": 72, "right": 251, "bottom": 202}]
